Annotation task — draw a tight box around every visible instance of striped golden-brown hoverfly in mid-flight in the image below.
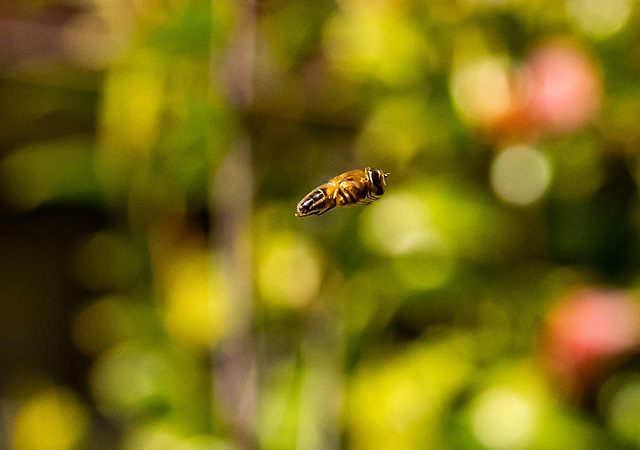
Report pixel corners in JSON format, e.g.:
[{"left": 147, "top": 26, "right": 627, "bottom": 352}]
[{"left": 296, "top": 167, "right": 389, "bottom": 217}]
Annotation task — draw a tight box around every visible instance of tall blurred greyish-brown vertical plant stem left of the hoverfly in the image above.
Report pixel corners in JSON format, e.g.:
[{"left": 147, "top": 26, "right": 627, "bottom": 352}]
[{"left": 210, "top": 0, "right": 258, "bottom": 448}]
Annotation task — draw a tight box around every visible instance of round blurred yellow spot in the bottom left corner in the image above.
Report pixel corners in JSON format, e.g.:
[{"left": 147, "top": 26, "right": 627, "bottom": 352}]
[{"left": 13, "top": 388, "right": 90, "bottom": 450}]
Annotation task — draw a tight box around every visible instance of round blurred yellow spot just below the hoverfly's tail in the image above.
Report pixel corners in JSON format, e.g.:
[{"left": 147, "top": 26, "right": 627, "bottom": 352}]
[{"left": 258, "top": 234, "right": 320, "bottom": 307}]
